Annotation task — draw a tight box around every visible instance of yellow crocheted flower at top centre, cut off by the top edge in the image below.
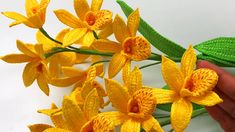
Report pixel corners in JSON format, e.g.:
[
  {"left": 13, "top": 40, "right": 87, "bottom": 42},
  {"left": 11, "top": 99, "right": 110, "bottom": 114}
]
[{"left": 54, "top": 0, "right": 112, "bottom": 47}]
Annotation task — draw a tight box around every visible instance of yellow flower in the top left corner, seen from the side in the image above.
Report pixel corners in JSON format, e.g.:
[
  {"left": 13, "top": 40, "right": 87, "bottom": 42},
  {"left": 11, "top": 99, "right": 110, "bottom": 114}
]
[{"left": 2, "top": 0, "right": 50, "bottom": 28}]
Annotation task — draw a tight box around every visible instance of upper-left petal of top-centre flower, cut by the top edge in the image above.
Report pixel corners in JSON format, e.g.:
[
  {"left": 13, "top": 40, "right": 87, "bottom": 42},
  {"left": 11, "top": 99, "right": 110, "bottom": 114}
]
[{"left": 74, "top": 0, "right": 90, "bottom": 20}]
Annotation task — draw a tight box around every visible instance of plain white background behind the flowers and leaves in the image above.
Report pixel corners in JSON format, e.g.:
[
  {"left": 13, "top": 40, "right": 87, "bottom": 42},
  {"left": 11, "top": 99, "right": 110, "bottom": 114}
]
[{"left": 0, "top": 0, "right": 235, "bottom": 132}]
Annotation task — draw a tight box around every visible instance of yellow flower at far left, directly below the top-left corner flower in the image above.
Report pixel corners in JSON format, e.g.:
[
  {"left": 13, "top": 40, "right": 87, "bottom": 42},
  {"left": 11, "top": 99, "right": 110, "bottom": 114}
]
[{"left": 1, "top": 41, "right": 49, "bottom": 95}]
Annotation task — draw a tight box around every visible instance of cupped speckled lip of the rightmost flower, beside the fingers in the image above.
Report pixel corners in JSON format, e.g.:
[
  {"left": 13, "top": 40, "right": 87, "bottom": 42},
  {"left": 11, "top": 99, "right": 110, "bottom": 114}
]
[{"left": 180, "top": 68, "right": 218, "bottom": 96}]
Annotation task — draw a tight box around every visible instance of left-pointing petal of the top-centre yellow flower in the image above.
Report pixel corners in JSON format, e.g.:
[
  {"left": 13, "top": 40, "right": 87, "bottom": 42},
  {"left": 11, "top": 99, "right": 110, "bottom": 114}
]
[{"left": 54, "top": 9, "right": 84, "bottom": 28}]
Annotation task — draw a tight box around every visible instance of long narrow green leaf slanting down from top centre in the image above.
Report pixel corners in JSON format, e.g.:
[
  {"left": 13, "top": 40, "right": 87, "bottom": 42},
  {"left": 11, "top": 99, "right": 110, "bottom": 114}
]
[{"left": 117, "top": 0, "right": 185, "bottom": 58}]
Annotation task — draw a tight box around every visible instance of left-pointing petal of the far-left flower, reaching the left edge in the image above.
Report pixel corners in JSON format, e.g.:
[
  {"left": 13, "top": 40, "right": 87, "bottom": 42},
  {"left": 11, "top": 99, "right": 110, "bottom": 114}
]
[{"left": 1, "top": 54, "right": 33, "bottom": 63}]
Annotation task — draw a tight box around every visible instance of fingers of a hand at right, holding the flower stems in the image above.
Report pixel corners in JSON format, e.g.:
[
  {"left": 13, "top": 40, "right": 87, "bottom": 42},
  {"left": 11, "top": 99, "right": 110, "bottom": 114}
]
[{"left": 197, "top": 61, "right": 235, "bottom": 132}]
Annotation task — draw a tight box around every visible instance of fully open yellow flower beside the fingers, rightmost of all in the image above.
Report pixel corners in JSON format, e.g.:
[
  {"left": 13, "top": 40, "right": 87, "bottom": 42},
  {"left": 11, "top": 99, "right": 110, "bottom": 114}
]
[{"left": 153, "top": 46, "right": 222, "bottom": 132}]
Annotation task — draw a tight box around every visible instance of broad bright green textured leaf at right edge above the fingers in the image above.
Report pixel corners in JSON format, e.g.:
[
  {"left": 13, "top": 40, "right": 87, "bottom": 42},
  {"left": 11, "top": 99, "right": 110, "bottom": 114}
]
[{"left": 194, "top": 37, "right": 235, "bottom": 64}]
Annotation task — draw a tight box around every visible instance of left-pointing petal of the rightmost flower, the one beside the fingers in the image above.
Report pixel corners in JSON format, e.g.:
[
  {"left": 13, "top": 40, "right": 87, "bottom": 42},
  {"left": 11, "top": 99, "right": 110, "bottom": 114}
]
[{"left": 152, "top": 88, "right": 176, "bottom": 104}]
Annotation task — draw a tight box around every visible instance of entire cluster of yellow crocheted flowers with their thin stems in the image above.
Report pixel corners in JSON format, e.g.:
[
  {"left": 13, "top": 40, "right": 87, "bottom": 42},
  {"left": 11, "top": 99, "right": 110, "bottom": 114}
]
[{"left": 1, "top": 0, "right": 222, "bottom": 132}]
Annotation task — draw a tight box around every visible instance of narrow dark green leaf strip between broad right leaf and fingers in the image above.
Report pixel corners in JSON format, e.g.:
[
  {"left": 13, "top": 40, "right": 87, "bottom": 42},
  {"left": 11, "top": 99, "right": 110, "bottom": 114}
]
[{"left": 197, "top": 54, "right": 235, "bottom": 67}]
